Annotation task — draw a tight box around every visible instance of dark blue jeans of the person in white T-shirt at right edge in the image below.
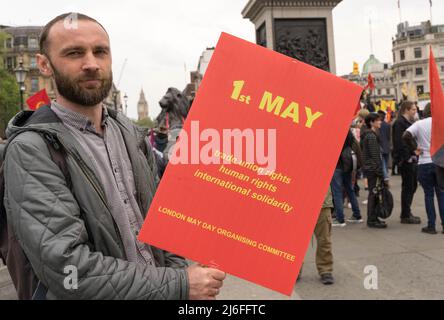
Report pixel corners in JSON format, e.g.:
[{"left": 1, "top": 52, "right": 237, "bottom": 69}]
[{"left": 418, "top": 163, "right": 444, "bottom": 228}]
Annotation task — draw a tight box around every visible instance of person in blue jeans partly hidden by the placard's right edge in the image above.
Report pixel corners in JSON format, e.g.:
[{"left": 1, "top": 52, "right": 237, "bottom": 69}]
[{"left": 330, "top": 130, "right": 362, "bottom": 227}]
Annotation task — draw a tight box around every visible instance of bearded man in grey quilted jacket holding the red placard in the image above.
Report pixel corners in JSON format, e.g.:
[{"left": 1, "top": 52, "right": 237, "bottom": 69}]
[{"left": 4, "top": 14, "right": 225, "bottom": 299}]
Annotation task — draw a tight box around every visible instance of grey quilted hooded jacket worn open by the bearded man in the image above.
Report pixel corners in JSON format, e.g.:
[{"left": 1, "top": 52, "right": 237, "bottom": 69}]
[{"left": 4, "top": 107, "right": 189, "bottom": 299}]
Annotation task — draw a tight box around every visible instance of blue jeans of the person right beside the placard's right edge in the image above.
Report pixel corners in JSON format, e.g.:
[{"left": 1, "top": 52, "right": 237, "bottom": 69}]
[{"left": 330, "top": 168, "right": 361, "bottom": 222}]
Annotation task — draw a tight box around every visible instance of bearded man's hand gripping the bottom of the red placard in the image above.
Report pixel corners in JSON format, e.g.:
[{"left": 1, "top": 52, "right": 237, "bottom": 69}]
[{"left": 187, "top": 264, "right": 226, "bottom": 300}]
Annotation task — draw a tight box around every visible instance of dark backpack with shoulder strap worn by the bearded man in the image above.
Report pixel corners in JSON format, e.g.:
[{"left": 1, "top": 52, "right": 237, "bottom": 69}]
[{"left": 0, "top": 107, "right": 71, "bottom": 300}]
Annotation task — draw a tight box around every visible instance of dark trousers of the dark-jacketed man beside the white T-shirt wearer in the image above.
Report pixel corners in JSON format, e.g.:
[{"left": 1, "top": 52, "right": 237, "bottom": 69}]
[{"left": 399, "top": 161, "right": 418, "bottom": 219}]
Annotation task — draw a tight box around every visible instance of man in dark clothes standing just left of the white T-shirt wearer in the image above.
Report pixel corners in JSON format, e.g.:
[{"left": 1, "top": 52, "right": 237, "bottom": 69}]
[{"left": 393, "top": 101, "right": 421, "bottom": 224}]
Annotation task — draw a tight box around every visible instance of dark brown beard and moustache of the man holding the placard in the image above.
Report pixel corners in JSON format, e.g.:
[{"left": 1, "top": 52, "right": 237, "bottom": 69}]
[{"left": 52, "top": 65, "right": 113, "bottom": 107}]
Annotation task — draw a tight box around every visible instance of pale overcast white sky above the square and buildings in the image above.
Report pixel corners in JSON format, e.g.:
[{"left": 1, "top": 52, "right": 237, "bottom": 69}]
[{"left": 0, "top": 0, "right": 444, "bottom": 118}]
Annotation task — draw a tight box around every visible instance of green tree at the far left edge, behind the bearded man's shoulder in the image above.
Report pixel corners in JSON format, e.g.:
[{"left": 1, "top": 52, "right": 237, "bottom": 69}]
[{"left": 0, "top": 68, "right": 20, "bottom": 138}]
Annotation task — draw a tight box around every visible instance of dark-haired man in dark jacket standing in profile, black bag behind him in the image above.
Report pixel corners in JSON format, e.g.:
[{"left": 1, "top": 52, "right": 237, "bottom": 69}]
[{"left": 362, "top": 113, "right": 387, "bottom": 229}]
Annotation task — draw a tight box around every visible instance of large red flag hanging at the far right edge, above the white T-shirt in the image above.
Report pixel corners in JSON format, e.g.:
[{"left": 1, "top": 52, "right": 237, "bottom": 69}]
[{"left": 429, "top": 48, "right": 444, "bottom": 167}]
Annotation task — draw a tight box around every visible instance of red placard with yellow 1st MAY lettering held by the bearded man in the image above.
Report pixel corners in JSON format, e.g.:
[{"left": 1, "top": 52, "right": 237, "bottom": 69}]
[{"left": 139, "top": 33, "right": 362, "bottom": 295}]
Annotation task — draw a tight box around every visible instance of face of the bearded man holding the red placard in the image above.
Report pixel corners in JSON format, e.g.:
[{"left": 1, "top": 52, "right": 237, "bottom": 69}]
[{"left": 39, "top": 20, "right": 112, "bottom": 107}]
